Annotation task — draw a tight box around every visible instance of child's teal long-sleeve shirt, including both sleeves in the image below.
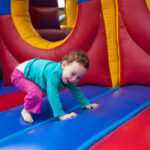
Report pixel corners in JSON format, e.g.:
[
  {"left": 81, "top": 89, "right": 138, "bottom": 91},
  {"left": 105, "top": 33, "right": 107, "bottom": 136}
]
[{"left": 24, "top": 58, "right": 89, "bottom": 117}]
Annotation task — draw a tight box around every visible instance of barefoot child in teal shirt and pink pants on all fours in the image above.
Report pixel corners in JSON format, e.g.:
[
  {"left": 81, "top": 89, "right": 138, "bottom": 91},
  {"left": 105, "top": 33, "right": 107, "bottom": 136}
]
[{"left": 11, "top": 50, "right": 99, "bottom": 123}]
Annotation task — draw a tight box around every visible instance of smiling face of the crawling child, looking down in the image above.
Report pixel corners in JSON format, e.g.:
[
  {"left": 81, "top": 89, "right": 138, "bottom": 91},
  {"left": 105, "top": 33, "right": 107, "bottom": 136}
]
[{"left": 62, "top": 61, "right": 87, "bottom": 84}]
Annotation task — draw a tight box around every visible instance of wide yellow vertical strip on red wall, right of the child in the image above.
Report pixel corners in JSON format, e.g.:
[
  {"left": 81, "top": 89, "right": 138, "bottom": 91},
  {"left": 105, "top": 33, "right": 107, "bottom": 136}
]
[{"left": 101, "top": 0, "right": 119, "bottom": 87}]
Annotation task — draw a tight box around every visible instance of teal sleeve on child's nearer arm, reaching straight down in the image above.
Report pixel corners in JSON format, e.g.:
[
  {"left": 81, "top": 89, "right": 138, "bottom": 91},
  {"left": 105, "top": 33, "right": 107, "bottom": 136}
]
[{"left": 47, "top": 79, "right": 66, "bottom": 117}]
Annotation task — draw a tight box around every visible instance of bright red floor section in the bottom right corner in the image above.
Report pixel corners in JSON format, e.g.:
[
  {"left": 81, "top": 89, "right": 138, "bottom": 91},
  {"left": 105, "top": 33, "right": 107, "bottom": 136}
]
[{"left": 89, "top": 106, "right": 150, "bottom": 150}]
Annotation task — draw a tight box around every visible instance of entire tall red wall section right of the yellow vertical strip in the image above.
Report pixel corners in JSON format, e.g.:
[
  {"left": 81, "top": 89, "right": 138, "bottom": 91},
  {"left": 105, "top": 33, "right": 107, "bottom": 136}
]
[{"left": 118, "top": 0, "right": 150, "bottom": 86}]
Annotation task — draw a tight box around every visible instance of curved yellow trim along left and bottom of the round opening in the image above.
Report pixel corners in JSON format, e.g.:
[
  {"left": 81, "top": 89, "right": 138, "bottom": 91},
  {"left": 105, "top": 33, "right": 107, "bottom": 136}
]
[{"left": 11, "top": 0, "right": 76, "bottom": 49}]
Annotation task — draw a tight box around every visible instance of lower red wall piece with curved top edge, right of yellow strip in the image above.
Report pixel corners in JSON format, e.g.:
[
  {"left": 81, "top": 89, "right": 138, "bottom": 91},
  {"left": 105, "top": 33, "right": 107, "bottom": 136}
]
[{"left": 119, "top": 17, "right": 150, "bottom": 86}]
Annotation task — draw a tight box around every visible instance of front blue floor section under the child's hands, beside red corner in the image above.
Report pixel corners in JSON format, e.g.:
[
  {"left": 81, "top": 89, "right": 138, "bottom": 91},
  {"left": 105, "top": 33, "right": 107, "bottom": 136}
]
[{"left": 0, "top": 86, "right": 150, "bottom": 150}]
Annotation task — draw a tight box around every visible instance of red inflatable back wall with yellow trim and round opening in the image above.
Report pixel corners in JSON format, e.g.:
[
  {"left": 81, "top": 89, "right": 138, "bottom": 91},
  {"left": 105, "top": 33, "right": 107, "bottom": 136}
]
[{"left": 0, "top": 0, "right": 150, "bottom": 110}]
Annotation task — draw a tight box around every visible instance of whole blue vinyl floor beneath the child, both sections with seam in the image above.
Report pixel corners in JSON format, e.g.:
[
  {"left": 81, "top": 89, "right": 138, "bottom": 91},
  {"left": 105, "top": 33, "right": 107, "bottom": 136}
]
[{"left": 0, "top": 86, "right": 150, "bottom": 150}]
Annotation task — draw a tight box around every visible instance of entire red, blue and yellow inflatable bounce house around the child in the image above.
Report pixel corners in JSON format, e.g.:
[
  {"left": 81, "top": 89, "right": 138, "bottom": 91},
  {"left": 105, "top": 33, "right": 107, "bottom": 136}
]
[{"left": 0, "top": 0, "right": 150, "bottom": 150}]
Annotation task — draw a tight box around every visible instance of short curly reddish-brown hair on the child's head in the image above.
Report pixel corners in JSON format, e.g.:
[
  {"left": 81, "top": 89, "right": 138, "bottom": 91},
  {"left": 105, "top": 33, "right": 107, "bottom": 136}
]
[{"left": 62, "top": 50, "right": 90, "bottom": 69}]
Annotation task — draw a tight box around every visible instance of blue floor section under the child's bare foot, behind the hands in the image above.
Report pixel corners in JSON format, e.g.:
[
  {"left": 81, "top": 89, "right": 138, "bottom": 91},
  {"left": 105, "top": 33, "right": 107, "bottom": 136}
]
[{"left": 0, "top": 86, "right": 112, "bottom": 139}]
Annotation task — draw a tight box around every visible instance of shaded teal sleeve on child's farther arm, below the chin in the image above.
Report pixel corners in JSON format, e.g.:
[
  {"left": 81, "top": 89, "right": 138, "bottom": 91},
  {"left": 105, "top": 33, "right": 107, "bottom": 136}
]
[{"left": 68, "top": 83, "right": 90, "bottom": 109}]
